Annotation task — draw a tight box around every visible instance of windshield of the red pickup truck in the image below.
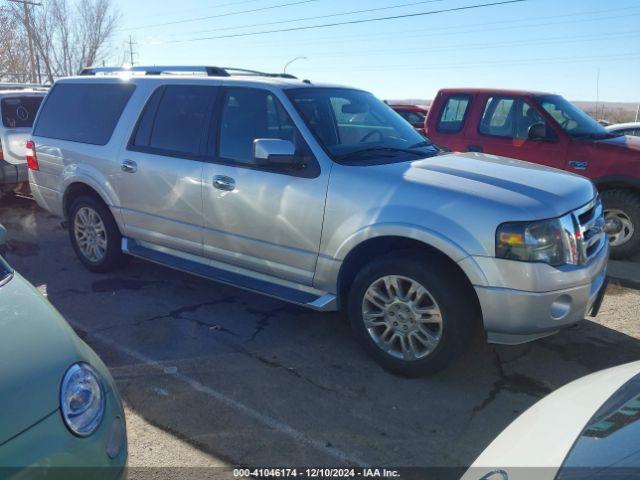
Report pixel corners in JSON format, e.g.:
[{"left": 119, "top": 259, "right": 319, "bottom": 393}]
[{"left": 538, "top": 95, "right": 616, "bottom": 139}]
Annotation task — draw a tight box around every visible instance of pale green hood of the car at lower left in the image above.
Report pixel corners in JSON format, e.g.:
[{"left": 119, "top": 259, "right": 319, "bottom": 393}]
[{"left": 0, "top": 273, "right": 82, "bottom": 445}]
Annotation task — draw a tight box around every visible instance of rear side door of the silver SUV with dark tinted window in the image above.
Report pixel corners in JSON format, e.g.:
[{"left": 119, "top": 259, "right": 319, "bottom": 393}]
[{"left": 113, "top": 83, "right": 218, "bottom": 255}]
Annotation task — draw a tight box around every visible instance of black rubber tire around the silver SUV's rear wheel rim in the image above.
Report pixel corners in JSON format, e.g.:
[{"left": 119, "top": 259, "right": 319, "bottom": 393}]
[{"left": 68, "top": 196, "right": 128, "bottom": 273}]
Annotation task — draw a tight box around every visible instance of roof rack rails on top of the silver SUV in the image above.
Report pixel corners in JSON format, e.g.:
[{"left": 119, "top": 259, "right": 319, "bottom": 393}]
[{"left": 80, "top": 65, "right": 297, "bottom": 79}]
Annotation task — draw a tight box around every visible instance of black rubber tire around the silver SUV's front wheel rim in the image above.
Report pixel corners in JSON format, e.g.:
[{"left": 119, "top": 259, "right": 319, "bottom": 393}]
[{"left": 347, "top": 251, "right": 478, "bottom": 377}]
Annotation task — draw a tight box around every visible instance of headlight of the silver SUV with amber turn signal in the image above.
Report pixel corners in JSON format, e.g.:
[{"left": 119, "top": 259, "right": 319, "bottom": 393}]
[{"left": 496, "top": 215, "right": 580, "bottom": 266}]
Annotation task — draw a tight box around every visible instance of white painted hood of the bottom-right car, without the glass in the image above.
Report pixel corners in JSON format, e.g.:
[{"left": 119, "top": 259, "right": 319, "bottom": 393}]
[{"left": 462, "top": 362, "right": 640, "bottom": 480}]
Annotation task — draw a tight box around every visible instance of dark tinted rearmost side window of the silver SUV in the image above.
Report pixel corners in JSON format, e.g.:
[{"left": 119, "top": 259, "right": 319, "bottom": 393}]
[{"left": 34, "top": 83, "right": 135, "bottom": 145}]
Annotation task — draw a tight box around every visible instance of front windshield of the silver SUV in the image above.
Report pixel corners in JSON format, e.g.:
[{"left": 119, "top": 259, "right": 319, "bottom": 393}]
[{"left": 287, "top": 88, "right": 439, "bottom": 163}]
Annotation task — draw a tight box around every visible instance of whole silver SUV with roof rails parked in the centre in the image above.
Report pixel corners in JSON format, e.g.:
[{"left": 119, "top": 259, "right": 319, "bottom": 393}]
[{"left": 28, "top": 67, "right": 608, "bottom": 375}]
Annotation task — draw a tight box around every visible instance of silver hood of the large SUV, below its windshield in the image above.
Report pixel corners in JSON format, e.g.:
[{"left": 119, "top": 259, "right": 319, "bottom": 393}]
[{"left": 394, "top": 153, "right": 596, "bottom": 221}]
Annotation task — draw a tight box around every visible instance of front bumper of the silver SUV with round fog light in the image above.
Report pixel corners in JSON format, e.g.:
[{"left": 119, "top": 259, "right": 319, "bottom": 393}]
[{"left": 474, "top": 245, "right": 609, "bottom": 345}]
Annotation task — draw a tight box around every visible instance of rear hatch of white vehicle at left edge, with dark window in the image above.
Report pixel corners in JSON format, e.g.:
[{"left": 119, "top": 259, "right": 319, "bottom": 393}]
[{"left": 0, "top": 93, "right": 44, "bottom": 165}]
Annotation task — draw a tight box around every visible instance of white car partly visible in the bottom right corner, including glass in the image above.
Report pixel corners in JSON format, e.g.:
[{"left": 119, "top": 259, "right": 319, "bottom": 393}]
[{"left": 462, "top": 362, "right": 640, "bottom": 480}]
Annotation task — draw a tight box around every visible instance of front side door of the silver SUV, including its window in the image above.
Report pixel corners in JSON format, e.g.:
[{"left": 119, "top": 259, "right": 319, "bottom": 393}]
[{"left": 203, "top": 87, "right": 328, "bottom": 285}]
